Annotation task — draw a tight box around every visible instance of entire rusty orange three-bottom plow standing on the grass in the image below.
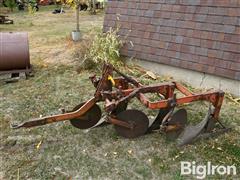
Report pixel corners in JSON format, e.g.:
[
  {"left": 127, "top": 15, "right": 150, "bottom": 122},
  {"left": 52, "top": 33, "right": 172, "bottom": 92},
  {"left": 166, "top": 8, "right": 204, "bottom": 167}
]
[{"left": 12, "top": 64, "right": 228, "bottom": 146}]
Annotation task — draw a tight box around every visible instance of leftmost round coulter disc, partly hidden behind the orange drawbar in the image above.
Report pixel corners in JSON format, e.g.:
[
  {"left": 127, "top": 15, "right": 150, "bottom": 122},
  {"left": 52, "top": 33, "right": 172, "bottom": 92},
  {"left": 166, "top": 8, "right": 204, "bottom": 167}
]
[{"left": 70, "top": 103, "right": 102, "bottom": 129}]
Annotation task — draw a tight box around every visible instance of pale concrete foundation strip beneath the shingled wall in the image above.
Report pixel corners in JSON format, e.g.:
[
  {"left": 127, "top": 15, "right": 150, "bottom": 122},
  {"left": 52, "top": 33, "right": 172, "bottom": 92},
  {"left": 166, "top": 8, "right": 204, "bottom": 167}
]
[{"left": 133, "top": 60, "right": 240, "bottom": 97}]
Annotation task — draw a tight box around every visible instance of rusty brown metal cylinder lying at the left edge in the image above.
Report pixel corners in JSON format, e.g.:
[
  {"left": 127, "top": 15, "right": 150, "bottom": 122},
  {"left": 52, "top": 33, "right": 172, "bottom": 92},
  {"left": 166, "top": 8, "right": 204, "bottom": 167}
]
[{"left": 0, "top": 32, "right": 31, "bottom": 73}]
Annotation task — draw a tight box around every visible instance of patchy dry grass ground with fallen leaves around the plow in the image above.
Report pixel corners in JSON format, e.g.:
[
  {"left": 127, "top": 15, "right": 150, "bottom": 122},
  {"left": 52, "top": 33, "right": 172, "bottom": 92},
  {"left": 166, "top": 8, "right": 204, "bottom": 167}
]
[{"left": 0, "top": 6, "right": 240, "bottom": 180}]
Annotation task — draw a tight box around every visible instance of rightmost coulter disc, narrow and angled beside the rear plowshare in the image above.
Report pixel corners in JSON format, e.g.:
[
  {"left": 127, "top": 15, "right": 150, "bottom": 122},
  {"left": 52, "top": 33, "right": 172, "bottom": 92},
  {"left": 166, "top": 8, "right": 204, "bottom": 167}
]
[{"left": 166, "top": 109, "right": 187, "bottom": 140}]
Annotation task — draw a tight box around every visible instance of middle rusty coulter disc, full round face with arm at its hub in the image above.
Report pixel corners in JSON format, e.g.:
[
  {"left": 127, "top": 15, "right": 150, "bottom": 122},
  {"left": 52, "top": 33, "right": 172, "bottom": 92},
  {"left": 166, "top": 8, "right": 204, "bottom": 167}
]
[{"left": 115, "top": 109, "right": 149, "bottom": 138}]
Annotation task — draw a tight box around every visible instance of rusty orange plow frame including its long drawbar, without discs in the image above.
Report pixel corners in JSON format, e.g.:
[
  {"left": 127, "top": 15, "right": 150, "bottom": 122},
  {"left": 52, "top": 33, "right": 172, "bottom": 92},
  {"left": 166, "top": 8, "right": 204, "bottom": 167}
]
[{"left": 12, "top": 64, "right": 224, "bottom": 129}]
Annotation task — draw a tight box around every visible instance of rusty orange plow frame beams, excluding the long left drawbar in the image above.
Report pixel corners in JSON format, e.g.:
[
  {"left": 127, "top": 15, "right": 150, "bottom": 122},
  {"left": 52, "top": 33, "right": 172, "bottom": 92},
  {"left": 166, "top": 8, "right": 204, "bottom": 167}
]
[{"left": 101, "top": 66, "right": 224, "bottom": 124}]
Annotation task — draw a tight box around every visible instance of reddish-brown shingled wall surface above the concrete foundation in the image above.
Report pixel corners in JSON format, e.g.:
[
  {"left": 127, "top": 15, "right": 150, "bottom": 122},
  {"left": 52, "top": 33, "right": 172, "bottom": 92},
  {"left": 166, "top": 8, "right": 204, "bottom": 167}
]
[{"left": 104, "top": 0, "right": 240, "bottom": 80}]
